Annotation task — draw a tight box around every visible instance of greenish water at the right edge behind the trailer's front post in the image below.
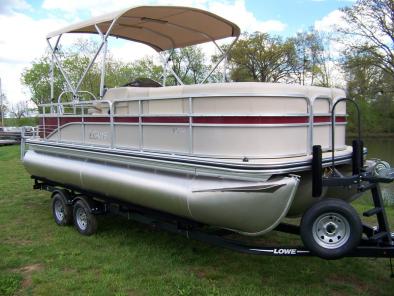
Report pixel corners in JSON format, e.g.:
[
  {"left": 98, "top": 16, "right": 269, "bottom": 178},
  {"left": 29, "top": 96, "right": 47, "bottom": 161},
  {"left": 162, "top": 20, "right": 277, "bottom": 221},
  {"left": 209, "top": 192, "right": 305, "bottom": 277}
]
[{"left": 348, "top": 138, "right": 394, "bottom": 206}]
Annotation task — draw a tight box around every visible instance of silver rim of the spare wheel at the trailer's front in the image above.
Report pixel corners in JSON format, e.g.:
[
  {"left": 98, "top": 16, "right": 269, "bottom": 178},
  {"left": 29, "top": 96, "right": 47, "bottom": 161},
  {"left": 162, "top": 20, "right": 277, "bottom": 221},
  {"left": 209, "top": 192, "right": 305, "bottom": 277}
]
[{"left": 312, "top": 213, "right": 350, "bottom": 249}]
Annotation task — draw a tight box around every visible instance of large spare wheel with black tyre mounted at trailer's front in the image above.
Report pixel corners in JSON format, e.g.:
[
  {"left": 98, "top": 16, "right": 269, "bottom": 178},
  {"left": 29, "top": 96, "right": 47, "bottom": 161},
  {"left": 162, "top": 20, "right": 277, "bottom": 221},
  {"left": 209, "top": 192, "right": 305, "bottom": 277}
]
[{"left": 300, "top": 199, "right": 362, "bottom": 259}]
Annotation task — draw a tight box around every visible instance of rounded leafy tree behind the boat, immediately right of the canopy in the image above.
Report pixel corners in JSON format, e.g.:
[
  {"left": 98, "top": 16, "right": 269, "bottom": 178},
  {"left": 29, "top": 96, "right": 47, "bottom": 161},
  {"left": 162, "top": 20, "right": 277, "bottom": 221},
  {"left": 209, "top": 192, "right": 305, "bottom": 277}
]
[{"left": 229, "top": 32, "right": 296, "bottom": 82}]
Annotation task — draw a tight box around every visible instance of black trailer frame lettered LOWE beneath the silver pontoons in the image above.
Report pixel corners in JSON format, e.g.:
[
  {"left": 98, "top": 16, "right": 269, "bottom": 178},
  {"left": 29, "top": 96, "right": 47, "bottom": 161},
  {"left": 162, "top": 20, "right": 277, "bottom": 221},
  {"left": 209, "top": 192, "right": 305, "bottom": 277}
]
[{"left": 32, "top": 176, "right": 394, "bottom": 258}]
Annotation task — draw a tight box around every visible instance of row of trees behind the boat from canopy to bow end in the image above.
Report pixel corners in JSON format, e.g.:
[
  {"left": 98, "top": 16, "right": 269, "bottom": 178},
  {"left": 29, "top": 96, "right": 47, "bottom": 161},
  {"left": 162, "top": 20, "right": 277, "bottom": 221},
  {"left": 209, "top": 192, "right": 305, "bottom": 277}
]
[{"left": 229, "top": 29, "right": 332, "bottom": 87}]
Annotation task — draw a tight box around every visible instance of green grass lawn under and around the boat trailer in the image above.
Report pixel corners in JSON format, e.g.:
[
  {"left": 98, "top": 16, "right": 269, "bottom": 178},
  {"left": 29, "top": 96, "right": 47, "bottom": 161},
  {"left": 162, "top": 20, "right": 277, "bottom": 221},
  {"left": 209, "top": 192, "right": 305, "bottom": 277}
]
[{"left": 0, "top": 146, "right": 394, "bottom": 295}]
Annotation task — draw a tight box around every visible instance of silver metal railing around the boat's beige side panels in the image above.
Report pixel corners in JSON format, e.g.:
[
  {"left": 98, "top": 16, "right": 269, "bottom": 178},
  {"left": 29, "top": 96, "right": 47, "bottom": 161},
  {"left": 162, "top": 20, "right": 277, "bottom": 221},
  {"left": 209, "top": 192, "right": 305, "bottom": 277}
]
[{"left": 33, "top": 94, "right": 346, "bottom": 155}]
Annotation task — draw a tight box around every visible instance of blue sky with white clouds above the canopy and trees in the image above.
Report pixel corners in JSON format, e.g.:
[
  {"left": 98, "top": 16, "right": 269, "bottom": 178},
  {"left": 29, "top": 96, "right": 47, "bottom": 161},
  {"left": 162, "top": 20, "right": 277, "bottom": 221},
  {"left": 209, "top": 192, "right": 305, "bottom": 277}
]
[{"left": 0, "top": 0, "right": 354, "bottom": 104}]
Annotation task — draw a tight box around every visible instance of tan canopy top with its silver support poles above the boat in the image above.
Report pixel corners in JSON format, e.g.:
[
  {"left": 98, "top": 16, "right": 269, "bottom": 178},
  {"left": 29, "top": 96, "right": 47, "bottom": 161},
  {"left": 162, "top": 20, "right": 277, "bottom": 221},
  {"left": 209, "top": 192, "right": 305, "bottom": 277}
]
[{"left": 47, "top": 6, "right": 240, "bottom": 101}]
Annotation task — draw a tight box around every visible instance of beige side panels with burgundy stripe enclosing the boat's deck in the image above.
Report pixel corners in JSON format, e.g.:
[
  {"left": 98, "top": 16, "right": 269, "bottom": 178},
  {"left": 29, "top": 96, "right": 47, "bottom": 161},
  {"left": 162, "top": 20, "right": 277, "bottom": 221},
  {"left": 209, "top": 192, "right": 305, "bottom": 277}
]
[{"left": 35, "top": 88, "right": 346, "bottom": 158}]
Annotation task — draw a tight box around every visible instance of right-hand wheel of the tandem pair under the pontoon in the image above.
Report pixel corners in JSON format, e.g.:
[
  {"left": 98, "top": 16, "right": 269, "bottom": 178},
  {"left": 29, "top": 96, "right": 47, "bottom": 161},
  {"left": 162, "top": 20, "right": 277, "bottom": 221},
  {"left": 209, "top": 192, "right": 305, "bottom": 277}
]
[{"left": 73, "top": 200, "right": 97, "bottom": 235}]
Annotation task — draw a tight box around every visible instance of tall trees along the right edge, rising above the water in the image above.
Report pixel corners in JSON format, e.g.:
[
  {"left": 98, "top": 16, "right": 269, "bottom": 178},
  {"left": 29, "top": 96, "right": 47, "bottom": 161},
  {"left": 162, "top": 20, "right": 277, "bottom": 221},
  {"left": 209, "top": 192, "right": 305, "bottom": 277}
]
[{"left": 338, "top": 0, "right": 394, "bottom": 133}]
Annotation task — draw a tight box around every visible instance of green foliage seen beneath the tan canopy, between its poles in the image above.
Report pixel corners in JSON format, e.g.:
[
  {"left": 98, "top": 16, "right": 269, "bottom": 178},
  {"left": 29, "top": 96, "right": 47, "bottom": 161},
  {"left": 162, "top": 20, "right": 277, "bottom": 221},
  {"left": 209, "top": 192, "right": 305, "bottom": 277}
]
[{"left": 21, "top": 41, "right": 214, "bottom": 106}]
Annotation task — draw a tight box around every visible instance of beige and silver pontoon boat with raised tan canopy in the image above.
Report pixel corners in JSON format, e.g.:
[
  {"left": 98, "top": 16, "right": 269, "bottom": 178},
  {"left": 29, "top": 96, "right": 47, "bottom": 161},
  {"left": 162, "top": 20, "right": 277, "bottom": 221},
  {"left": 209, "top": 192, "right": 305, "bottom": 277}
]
[{"left": 23, "top": 6, "right": 394, "bottom": 257}]
